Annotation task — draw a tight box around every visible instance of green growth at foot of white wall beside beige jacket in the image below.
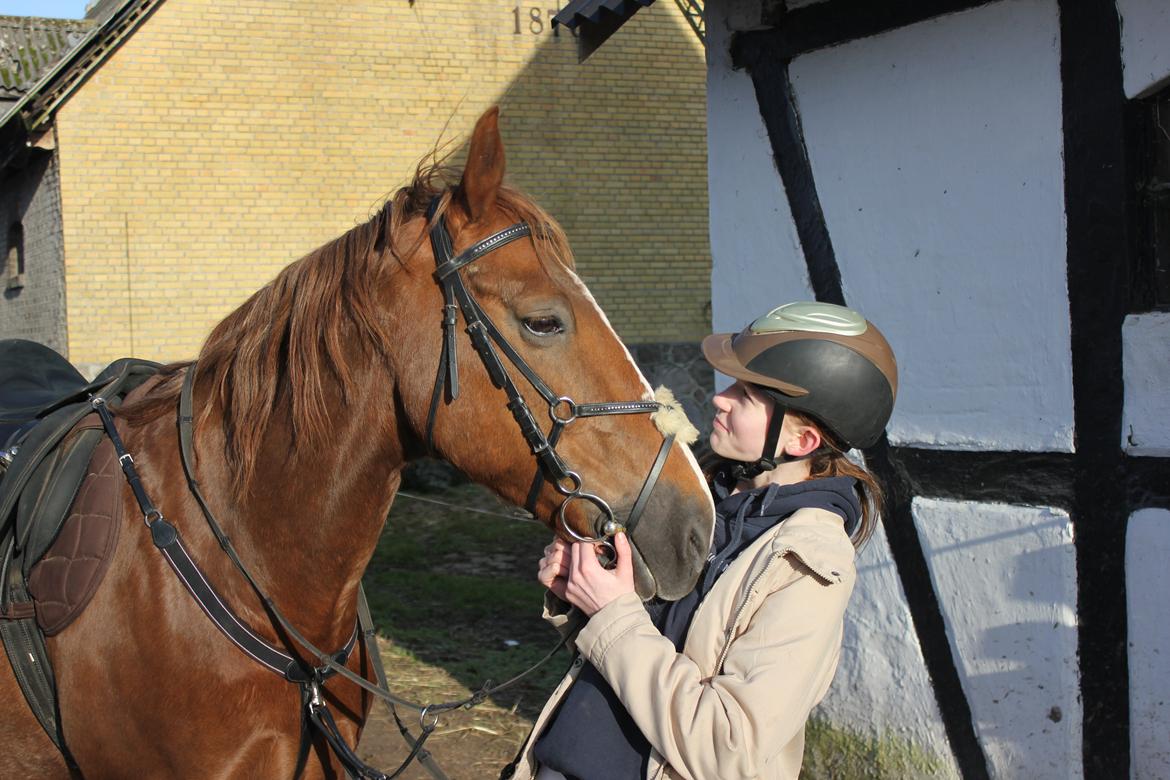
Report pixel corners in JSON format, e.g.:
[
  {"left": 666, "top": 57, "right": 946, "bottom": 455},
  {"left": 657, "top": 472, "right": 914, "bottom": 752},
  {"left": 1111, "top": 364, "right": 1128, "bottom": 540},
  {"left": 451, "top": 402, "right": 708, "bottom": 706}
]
[{"left": 800, "top": 718, "right": 950, "bottom": 780}]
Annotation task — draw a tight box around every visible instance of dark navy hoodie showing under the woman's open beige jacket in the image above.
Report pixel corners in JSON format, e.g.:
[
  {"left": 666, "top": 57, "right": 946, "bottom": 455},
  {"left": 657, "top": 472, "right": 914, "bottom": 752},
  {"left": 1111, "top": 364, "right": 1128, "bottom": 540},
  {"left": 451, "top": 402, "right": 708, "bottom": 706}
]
[{"left": 534, "top": 475, "right": 861, "bottom": 780}]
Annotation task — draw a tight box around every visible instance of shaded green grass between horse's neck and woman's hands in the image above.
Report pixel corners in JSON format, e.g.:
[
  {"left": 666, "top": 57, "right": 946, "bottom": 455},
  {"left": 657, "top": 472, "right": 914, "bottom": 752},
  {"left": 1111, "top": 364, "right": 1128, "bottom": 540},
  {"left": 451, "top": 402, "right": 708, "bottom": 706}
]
[{"left": 364, "top": 484, "right": 569, "bottom": 710}]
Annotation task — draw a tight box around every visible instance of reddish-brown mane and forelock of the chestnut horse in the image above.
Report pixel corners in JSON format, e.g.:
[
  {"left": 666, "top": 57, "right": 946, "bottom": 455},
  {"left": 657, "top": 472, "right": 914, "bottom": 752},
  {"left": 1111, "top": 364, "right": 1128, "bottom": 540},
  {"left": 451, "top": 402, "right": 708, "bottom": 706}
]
[{"left": 119, "top": 152, "right": 573, "bottom": 497}]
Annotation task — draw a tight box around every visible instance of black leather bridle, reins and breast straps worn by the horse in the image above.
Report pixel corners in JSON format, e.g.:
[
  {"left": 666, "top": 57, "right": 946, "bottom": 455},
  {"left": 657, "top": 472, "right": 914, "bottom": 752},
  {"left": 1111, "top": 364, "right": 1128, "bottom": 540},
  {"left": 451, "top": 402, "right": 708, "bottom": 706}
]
[{"left": 80, "top": 198, "right": 675, "bottom": 780}]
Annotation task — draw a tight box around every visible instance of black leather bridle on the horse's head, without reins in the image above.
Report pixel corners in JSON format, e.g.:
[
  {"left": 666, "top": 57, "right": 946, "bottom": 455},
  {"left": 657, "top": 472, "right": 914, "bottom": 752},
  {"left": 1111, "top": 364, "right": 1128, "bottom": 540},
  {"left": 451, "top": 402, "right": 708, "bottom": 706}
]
[{"left": 426, "top": 198, "right": 674, "bottom": 551}]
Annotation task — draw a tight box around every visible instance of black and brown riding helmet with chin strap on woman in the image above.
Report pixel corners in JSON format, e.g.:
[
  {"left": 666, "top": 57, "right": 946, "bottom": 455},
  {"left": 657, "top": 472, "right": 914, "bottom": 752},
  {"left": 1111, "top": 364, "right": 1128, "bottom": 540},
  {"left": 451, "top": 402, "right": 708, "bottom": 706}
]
[{"left": 703, "top": 302, "right": 897, "bottom": 477}]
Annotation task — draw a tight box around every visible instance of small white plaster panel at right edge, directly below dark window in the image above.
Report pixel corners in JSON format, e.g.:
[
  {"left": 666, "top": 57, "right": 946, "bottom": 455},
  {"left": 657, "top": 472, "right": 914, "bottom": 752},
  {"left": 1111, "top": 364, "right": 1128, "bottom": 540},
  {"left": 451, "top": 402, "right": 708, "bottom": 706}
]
[{"left": 1121, "top": 311, "right": 1170, "bottom": 458}]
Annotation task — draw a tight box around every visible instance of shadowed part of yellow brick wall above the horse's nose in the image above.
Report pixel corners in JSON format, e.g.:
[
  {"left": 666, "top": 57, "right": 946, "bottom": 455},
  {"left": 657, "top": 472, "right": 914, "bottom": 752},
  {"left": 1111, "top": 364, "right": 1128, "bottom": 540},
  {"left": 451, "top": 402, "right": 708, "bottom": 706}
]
[{"left": 442, "top": 4, "right": 714, "bottom": 432}]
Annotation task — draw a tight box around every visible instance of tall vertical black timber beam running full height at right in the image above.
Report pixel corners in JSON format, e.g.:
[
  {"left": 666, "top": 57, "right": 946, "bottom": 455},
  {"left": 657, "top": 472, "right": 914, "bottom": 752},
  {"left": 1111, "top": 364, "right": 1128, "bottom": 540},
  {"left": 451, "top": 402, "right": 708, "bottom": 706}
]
[{"left": 1059, "top": 0, "right": 1130, "bottom": 780}]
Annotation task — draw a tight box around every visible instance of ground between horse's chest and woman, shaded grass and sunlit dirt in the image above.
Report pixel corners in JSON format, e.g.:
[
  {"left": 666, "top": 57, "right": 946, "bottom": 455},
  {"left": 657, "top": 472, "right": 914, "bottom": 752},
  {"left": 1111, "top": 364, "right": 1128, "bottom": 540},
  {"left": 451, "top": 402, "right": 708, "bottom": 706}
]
[{"left": 348, "top": 485, "right": 569, "bottom": 780}]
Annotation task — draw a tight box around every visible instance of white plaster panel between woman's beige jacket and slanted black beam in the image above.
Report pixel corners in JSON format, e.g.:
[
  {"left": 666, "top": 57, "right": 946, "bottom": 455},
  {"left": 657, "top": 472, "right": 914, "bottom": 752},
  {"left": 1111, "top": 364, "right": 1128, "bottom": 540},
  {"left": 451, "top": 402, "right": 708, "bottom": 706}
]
[{"left": 815, "top": 525, "right": 959, "bottom": 778}]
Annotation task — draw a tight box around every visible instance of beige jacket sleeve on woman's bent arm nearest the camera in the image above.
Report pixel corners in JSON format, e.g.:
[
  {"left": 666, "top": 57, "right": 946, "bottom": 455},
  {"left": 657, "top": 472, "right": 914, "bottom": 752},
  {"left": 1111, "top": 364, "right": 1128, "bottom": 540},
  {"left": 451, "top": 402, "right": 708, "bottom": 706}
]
[{"left": 577, "top": 558, "right": 852, "bottom": 780}]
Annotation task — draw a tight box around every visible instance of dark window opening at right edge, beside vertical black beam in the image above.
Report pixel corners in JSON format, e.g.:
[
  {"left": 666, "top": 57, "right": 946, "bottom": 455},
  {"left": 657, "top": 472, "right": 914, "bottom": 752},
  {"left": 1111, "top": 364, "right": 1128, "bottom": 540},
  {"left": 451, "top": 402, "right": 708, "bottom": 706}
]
[{"left": 1129, "top": 88, "right": 1170, "bottom": 312}]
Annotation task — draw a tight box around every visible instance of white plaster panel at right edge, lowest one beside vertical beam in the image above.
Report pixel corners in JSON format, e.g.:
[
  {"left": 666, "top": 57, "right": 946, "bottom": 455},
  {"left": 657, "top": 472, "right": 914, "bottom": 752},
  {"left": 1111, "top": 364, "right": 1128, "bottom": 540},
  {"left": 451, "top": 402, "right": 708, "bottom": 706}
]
[{"left": 1126, "top": 509, "right": 1170, "bottom": 780}]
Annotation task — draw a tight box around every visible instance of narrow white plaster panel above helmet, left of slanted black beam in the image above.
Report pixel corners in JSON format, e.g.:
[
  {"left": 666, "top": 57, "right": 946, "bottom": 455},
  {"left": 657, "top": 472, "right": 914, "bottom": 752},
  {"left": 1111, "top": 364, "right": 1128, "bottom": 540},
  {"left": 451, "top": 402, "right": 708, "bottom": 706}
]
[{"left": 707, "top": 0, "right": 812, "bottom": 343}]
